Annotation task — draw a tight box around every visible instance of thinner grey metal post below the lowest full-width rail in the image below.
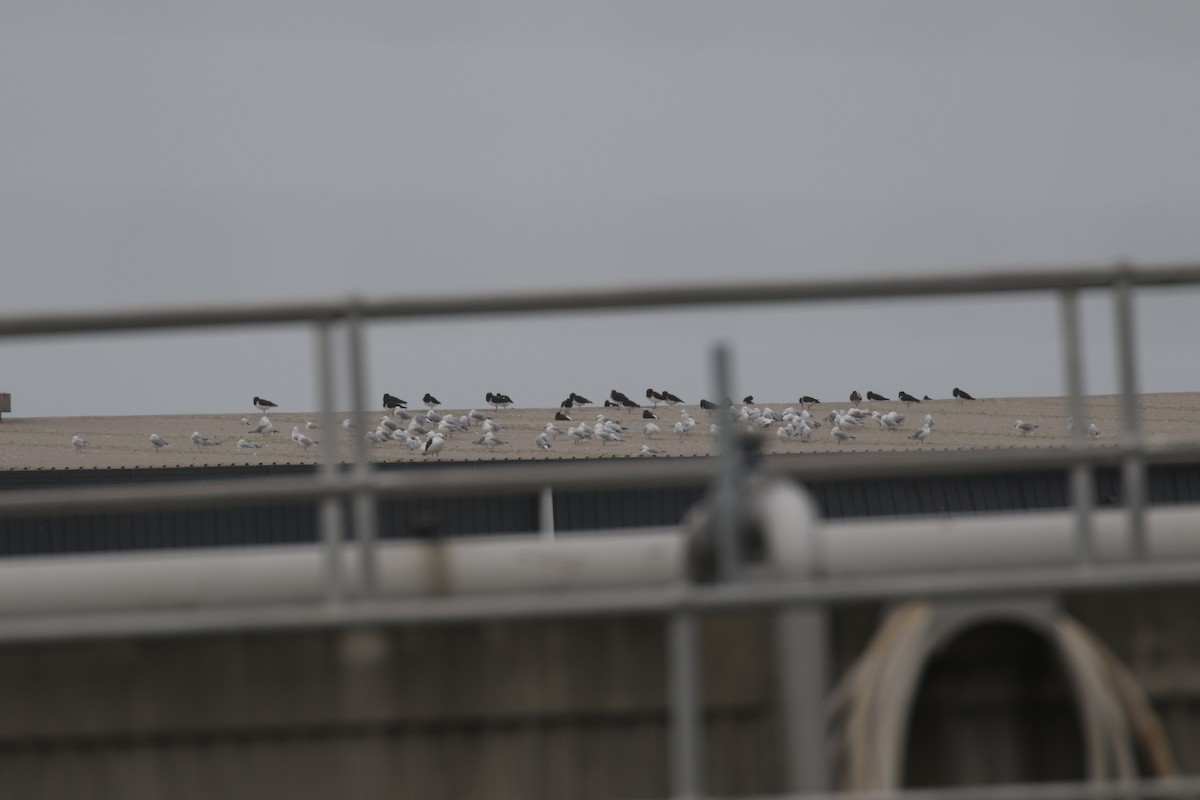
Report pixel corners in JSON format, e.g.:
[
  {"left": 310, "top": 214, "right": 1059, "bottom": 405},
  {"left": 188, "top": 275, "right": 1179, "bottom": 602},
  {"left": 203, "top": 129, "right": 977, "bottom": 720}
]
[{"left": 667, "top": 610, "right": 704, "bottom": 800}]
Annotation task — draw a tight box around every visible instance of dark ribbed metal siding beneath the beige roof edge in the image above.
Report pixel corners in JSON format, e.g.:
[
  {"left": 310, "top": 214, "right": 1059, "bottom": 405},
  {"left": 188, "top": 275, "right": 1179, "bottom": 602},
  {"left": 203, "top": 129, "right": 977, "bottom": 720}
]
[{"left": 7, "top": 462, "right": 1200, "bottom": 557}]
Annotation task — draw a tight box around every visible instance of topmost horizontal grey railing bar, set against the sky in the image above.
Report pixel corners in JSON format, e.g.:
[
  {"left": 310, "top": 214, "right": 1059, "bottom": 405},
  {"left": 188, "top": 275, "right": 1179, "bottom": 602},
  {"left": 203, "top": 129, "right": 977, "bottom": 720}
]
[{"left": 0, "top": 264, "right": 1200, "bottom": 337}]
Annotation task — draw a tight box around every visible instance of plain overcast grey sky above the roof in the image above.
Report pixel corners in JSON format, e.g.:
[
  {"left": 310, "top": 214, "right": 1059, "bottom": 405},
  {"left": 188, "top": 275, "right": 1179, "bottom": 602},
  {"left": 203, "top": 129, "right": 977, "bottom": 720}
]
[{"left": 0, "top": 0, "right": 1200, "bottom": 416}]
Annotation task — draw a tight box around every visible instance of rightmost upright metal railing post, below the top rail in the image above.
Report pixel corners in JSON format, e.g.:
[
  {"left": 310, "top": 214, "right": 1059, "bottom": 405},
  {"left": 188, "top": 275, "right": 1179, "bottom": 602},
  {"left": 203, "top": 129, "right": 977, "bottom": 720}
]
[{"left": 1114, "top": 272, "right": 1150, "bottom": 560}]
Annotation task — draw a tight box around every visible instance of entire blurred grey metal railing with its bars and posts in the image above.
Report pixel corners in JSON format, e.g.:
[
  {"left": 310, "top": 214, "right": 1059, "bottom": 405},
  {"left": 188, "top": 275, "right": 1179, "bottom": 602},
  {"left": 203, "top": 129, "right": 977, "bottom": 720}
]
[{"left": 0, "top": 264, "right": 1200, "bottom": 798}]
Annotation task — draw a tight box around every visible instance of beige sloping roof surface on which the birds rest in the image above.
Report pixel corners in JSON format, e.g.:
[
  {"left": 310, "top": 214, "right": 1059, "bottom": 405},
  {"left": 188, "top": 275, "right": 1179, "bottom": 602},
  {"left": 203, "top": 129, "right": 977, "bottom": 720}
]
[{"left": 0, "top": 392, "right": 1200, "bottom": 469}]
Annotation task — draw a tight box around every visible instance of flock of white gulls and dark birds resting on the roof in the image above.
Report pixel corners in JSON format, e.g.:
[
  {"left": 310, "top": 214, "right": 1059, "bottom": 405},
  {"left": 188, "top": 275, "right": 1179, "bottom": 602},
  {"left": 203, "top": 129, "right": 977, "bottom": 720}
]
[{"left": 71, "top": 386, "right": 1100, "bottom": 457}]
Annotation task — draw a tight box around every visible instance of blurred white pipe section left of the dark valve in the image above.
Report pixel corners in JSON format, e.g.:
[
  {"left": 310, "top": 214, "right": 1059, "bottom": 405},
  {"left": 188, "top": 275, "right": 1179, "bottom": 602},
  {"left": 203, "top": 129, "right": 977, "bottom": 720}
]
[{"left": 0, "top": 529, "right": 684, "bottom": 618}]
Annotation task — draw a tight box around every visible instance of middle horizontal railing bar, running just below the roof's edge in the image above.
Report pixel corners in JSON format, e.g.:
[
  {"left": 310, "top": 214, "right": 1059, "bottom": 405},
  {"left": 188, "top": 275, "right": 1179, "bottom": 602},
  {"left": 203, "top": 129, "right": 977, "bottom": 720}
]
[{"left": 0, "top": 445, "right": 1200, "bottom": 517}]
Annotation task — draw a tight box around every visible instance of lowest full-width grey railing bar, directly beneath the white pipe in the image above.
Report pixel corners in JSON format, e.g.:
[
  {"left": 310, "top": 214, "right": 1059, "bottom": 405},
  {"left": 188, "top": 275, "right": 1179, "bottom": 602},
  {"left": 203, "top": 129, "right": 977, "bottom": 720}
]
[{"left": 0, "top": 560, "right": 1200, "bottom": 642}]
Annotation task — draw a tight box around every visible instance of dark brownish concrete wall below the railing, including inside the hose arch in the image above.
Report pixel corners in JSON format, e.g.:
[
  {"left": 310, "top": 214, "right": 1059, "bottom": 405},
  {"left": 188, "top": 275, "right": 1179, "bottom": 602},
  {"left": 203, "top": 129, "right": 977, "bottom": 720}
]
[{"left": 0, "top": 589, "right": 1200, "bottom": 800}]
